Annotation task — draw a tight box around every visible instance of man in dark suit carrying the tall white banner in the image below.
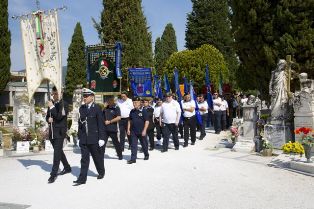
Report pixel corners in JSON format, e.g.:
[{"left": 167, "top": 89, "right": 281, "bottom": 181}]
[{"left": 46, "top": 87, "right": 71, "bottom": 183}]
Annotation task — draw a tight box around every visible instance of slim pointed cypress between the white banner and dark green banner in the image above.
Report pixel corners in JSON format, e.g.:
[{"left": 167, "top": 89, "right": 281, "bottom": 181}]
[{"left": 65, "top": 22, "right": 86, "bottom": 97}]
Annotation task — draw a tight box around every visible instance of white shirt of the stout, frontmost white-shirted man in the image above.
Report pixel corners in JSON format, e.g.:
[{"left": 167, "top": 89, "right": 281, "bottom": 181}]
[{"left": 160, "top": 99, "right": 181, "bottom": 124}]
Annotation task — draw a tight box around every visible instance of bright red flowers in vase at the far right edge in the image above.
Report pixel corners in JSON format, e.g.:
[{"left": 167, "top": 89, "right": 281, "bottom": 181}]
[{"left": 294, "top": 127, "right": 314, "bottom": 163}]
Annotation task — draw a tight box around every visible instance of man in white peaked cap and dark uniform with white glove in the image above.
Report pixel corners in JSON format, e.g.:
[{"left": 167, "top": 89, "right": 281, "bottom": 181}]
[{"left": 73, "top": 88, "right": 105, "bottom": 186}]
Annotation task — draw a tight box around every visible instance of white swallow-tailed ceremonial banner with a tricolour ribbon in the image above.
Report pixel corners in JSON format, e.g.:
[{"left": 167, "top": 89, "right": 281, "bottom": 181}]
[{"left": 21, "top": 10, "right": 62, "bottom": 101}]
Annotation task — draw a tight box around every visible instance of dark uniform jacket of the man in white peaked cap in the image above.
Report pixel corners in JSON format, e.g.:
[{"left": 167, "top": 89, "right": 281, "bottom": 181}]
[{"left": 78, "top": 103, "right": 105, "bottom": 144}]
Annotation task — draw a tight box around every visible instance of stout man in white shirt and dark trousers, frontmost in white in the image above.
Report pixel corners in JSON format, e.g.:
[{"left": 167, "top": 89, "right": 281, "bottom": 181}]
[{"left": 159, "top": 93, "right": 181, "bottom": 152}]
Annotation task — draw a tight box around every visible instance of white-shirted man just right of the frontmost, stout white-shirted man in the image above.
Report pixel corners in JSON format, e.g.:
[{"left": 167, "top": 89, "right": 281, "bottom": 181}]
[{"left": 181, "top": 94, "right": 196, "bottom": 147}]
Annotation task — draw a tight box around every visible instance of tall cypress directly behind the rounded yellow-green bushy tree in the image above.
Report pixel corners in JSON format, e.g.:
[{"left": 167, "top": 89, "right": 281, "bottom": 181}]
[{"left": 185, "top": 0, "right": 238, "bottom": 81}]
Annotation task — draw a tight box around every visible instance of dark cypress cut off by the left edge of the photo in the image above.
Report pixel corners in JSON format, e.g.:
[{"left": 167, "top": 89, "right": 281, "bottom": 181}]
[{"left": 0, "top": 0, "right": 11, "bottom": 93}]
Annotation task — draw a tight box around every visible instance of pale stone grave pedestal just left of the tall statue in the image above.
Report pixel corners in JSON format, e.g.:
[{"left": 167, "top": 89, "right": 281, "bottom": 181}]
[{"left": 233, "top": 100, "right": 257, "bottom": 153}]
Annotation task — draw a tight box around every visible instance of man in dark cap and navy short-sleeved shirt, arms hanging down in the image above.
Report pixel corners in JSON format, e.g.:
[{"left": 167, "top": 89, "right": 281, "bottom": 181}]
[{"left": 127, "top": 97, "right": 149, "bottom": 164}]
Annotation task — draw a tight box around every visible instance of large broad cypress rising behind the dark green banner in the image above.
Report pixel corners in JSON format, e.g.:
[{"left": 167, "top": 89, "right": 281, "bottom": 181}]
[{"left": 98, "top": 0, "right": 153, "bottom": 69}]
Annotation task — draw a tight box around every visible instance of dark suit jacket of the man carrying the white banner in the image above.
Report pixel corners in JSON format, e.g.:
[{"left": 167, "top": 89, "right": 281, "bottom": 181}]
[{"left": 46, "top": 100, "right": 68, "bottom": 139}]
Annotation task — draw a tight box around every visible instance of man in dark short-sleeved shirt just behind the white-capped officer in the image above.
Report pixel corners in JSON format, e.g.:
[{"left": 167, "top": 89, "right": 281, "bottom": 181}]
[{"left": 103, "top": 97, "right": 123, "bottom": 160}]
